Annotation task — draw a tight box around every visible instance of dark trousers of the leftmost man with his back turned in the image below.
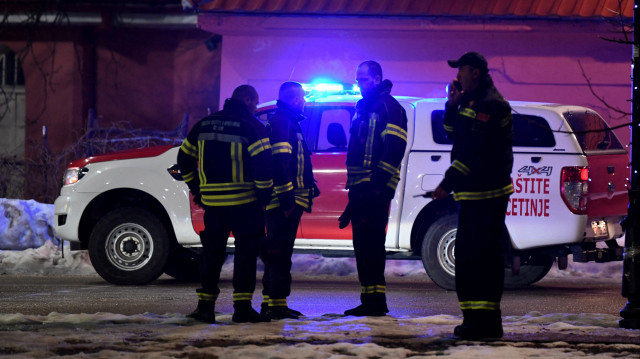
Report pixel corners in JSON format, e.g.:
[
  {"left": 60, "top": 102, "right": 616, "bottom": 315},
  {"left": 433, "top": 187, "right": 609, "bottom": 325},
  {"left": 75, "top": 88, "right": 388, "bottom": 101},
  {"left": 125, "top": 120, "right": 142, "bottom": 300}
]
[{"left": 200, "top": 202, "right": 265, "bottom": 295}]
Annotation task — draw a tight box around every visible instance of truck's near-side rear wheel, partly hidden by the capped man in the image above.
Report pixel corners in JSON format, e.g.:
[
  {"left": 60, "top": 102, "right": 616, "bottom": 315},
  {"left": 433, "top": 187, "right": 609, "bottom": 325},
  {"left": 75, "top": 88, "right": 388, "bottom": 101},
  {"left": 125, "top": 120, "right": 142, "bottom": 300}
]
[{"left": 422, "top": 214, "right": 458, "bottom": 290}]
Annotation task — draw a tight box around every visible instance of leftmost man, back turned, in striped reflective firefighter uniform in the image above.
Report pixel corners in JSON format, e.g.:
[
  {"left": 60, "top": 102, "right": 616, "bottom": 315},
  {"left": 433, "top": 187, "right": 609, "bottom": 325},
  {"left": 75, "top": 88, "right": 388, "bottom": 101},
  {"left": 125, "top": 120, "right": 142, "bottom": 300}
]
[{"left": 178, "top": 85, "right": 273, "bottom": 323}]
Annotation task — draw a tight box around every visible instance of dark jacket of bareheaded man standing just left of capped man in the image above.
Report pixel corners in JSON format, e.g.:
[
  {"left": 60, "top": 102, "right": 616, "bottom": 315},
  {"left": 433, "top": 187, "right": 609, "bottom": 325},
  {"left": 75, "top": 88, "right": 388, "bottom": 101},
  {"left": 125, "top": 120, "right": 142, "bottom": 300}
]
[{"left": 347, "top": 80, "right": 407, "bottom": 198}]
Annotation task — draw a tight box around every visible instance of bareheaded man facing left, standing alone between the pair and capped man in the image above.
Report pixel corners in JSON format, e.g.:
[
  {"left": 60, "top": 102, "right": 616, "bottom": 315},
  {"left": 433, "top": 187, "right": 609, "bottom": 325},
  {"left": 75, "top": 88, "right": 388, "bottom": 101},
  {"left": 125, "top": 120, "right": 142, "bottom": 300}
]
[{"left": 340, "top": 61, "right": 407, "bottom": 316}]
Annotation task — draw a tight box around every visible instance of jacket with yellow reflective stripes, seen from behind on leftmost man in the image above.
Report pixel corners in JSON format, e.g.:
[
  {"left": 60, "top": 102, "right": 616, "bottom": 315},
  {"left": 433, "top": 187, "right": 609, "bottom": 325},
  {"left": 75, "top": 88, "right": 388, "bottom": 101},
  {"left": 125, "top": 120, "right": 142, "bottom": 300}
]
[{"left": 178, "top": 99, "right": 273, "bottom": 206}]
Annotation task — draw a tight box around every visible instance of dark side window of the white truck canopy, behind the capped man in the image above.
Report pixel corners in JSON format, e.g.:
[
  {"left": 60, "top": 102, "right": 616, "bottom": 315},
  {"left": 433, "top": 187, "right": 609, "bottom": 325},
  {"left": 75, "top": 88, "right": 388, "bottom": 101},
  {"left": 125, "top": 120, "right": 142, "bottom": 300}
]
[{"left": 431, "top": 110, "right": 556, "bottom": 147}]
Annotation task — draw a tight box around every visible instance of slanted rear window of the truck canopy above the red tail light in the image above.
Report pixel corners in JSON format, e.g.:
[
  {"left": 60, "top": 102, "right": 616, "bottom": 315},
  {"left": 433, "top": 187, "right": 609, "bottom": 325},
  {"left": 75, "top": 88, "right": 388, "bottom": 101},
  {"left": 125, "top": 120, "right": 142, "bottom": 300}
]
[{"left": 562, "top": 111, "right": 623, "bottom": 152}]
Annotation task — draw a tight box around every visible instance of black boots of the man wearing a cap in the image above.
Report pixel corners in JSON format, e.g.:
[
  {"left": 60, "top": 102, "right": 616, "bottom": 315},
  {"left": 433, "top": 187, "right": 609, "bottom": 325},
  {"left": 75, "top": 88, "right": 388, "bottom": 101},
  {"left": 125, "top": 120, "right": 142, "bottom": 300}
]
[{"left": 453, "top": 309, "right": 503, "bottom": 340}]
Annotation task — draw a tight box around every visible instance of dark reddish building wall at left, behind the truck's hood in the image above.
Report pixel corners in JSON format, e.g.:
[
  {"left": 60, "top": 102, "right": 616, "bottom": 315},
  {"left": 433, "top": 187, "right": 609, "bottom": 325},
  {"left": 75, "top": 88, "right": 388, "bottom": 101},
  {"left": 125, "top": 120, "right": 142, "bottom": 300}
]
[{"left": 0, "top": 25, "right": 220, "bottom": 202}]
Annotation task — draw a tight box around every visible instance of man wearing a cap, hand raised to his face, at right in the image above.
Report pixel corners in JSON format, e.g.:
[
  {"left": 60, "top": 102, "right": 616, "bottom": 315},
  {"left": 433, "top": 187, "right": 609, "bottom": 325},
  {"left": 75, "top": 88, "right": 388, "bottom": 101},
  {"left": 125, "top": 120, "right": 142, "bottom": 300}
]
[{"left": 432, "top": 52, "right": 513, "bottom": 339}]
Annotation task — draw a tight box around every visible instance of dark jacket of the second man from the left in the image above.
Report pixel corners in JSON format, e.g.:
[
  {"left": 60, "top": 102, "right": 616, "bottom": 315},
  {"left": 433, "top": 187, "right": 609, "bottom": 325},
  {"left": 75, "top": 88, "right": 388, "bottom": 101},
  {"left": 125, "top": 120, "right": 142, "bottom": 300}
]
[{"left": 267, "top": 101, "right": 319, "bottom": 212}]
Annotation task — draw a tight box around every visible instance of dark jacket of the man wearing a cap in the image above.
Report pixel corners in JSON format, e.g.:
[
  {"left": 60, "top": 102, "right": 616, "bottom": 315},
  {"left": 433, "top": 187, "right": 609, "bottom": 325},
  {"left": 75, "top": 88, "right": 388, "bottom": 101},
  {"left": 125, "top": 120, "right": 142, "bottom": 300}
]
[{"left": 440, "top": 84, "right": 513, "bottom": 201}]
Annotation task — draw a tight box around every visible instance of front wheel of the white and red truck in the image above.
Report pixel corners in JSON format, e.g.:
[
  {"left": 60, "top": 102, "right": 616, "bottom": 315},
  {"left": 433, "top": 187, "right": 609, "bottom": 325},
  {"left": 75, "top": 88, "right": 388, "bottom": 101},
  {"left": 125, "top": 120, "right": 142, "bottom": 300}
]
[{"left": 89, "top": 207, "right": 170, "bottom": 285}]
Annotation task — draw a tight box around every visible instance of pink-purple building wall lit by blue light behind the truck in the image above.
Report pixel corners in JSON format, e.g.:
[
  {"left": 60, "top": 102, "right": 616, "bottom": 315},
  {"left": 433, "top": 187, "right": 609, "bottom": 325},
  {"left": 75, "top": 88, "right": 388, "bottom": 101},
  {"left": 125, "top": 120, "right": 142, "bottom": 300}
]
[{"left": 198, "top": 14, "right": 631, "bottom": 143}]
